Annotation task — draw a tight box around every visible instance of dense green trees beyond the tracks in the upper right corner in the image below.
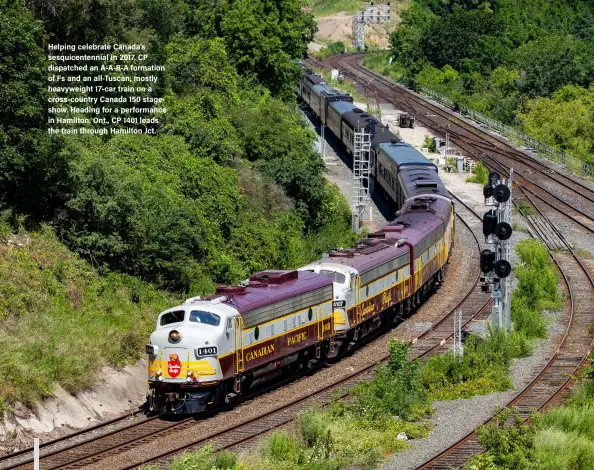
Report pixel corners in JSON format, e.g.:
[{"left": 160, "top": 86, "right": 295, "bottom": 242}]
[{"left": 384, "top": 0, "right": 594, "bottom": 161}]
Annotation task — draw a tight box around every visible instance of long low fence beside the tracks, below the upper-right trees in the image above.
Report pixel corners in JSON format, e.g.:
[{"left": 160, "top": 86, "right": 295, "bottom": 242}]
[{"left": 421, "top": 88, "right": 594, "bottom": 178}]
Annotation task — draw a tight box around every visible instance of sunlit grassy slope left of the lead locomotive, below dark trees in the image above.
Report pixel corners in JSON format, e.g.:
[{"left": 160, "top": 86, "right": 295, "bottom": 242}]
[{"left": 0, "top": 218, "right": 176, "bottom": 406}]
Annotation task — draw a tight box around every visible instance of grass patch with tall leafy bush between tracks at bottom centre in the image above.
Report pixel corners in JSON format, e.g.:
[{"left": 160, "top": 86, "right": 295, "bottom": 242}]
[{"left": 157, "top": 340, "right": 431, "bottom": 470}]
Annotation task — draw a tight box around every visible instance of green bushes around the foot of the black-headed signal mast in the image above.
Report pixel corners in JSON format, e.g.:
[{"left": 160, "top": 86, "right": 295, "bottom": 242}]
[{"left": 420, "top": 239, "right": 559, "bottom": 400}]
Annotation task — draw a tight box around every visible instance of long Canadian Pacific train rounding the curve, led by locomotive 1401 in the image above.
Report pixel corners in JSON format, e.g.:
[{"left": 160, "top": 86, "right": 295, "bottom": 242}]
[{"left": 146, "top": 67, "right": 454, "bottom": 414}]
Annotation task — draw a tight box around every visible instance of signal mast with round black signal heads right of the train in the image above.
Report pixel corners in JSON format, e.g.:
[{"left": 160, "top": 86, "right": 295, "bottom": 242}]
[{"left": 481, "top": 170, "right": 513, "bottom": 330}]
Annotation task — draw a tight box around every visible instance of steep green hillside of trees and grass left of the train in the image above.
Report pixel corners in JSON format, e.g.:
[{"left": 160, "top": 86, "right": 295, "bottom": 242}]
[{"left": 0, "top": 0, "right": 353, "bottom": 409}]
